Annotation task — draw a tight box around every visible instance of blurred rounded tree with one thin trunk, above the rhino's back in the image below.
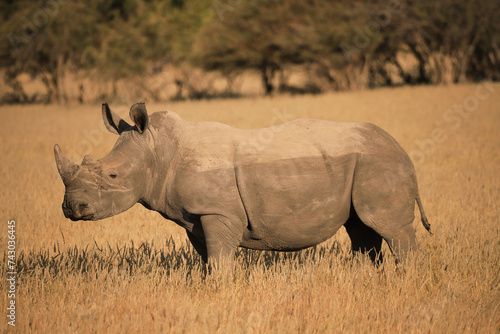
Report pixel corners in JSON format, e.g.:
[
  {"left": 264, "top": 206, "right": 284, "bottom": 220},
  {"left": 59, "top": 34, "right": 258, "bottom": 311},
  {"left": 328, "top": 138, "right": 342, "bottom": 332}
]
[{"left": 192, "top": 0, "right": 313, "bottom": 94}]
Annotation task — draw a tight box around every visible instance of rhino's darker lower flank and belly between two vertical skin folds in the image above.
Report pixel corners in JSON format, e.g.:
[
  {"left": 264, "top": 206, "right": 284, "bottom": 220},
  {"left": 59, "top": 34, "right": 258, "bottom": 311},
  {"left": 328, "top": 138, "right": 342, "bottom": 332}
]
[{"left": 236, "top": 155, "right": 355, "bottom": 250}]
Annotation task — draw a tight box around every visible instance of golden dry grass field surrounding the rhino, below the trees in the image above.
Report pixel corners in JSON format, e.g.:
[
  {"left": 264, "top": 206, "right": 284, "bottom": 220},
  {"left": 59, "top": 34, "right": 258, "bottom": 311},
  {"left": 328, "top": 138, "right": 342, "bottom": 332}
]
[{"left": 0, "top": 84, "right": 500, "bottom": 333}]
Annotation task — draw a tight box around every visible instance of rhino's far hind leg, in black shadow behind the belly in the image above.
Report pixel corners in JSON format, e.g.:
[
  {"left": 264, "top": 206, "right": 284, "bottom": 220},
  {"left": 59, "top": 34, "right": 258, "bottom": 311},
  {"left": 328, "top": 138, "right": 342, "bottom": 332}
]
[{"left": 344, "top": 207, "right": 382, "bottom": 265}]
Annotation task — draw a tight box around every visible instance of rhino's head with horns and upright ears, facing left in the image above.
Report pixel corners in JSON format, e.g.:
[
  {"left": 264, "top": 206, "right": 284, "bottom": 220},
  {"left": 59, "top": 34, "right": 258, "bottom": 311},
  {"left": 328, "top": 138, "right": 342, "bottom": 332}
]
[{"left": 54, "top": 103, "right": 154, "bottom": 220}]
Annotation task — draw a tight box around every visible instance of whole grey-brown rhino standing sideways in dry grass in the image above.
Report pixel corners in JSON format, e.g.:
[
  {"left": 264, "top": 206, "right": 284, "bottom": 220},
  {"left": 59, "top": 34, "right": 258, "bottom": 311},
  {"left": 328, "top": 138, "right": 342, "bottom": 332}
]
[{"left": 54, "top": 103, "right": 430, "bottom": 265}]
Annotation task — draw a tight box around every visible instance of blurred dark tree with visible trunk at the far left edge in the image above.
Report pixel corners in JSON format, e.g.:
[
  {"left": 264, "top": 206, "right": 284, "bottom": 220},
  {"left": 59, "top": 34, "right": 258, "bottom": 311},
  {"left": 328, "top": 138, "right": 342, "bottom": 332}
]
[{"left": 0, "top": 1, "right": 102, "bottom": 102}]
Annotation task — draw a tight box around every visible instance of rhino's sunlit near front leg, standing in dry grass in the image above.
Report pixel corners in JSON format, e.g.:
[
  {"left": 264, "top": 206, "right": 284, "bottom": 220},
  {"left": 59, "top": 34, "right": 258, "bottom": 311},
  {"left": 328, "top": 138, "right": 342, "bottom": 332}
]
[{"left": 201, "top": 215, "right": 242, "bottom": 273}]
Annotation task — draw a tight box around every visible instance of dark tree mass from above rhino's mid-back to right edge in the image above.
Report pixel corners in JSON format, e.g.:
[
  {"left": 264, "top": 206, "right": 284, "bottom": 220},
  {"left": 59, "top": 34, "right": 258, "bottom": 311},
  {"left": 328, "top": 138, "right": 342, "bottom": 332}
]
[{"left": 195, "top": 0, "right": 500, "bottom": 93}]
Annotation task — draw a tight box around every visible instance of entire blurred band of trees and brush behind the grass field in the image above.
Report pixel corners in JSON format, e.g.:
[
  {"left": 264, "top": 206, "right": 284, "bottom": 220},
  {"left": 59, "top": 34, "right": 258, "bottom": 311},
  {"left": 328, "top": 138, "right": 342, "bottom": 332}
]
[{"left": 0, "top": 0, "right": 500, "bottom": 103}]
